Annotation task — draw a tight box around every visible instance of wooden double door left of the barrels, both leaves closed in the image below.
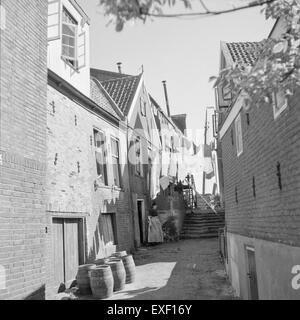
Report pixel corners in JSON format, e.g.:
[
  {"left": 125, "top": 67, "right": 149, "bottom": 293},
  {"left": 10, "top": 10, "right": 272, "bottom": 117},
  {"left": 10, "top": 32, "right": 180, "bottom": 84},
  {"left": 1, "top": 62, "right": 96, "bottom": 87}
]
[{"left": 52, "top": 218, "right": 84, "bottom": 291}]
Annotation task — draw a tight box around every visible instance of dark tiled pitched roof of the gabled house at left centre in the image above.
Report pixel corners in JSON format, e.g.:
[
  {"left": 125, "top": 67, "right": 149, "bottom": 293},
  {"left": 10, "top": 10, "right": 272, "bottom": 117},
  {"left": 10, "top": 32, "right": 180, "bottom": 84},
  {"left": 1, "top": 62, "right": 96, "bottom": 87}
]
[{"left": 91, "top": 69, "right": 142, "bottom": 115}]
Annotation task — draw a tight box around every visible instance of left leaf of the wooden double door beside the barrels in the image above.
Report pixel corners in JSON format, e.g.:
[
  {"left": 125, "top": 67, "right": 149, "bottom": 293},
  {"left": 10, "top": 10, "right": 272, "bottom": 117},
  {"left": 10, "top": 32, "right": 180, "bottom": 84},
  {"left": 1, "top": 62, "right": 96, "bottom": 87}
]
[{"left": 52, "top": 219, "right": 65, "bottom": 288}]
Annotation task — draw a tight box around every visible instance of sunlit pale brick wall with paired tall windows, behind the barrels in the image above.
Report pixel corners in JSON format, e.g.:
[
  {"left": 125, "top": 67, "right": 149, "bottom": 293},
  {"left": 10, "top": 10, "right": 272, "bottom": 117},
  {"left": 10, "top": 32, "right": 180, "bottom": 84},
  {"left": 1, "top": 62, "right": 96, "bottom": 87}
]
[{"left": 46, "top": 85, "right": 133, "bottom": 292}]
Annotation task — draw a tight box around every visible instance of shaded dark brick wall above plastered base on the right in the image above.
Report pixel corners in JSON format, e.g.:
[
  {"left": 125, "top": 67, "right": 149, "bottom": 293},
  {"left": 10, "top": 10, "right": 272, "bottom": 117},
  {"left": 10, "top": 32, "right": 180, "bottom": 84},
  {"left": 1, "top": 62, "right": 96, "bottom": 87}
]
[{"left": 221, "top": 91, "right": 300, "bottom": 246}]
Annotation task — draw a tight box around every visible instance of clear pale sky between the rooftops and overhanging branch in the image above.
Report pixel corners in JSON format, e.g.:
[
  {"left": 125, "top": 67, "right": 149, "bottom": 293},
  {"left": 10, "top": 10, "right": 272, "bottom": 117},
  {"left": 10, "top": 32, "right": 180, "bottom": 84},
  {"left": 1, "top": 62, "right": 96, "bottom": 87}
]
[{"left": 77, "top": 0, "right": 274, "bottom": 142}]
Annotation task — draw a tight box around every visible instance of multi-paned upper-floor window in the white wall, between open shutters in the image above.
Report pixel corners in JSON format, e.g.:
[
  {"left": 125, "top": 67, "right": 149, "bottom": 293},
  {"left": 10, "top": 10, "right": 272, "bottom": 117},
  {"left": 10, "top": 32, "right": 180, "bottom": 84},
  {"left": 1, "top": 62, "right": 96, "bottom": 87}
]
[{"left": 62, "top": 8, "right": 78, "bottom": 67}]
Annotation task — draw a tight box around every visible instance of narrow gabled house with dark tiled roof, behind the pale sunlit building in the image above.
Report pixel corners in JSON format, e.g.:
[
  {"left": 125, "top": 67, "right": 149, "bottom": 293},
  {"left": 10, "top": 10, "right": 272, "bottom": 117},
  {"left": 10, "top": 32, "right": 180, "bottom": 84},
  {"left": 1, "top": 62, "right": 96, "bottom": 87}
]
[{"left": 91, "top": 69, "right": 161, "bottom": 246}]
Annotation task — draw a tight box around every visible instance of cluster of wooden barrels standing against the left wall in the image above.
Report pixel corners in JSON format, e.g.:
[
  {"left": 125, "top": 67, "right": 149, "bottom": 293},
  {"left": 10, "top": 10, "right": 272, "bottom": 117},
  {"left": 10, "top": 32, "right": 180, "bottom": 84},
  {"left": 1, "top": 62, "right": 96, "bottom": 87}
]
[{"left": 76, "top": 251, "right": 136, "bottom": 299}]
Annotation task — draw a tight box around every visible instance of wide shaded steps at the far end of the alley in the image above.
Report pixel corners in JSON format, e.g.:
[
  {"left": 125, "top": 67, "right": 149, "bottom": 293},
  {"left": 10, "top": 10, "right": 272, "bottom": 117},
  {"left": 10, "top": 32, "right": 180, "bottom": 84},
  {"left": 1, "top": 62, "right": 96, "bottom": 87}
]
[{"left": 180, "top": 208, "right": 225, "bottom": 239}]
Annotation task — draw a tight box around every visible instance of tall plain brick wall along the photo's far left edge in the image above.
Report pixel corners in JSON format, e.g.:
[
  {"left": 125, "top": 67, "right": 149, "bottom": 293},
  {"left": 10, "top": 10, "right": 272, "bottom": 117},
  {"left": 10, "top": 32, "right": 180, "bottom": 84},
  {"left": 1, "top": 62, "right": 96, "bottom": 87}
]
[{"left": 0, "top": 0, "right": 47, "bottom": 299}]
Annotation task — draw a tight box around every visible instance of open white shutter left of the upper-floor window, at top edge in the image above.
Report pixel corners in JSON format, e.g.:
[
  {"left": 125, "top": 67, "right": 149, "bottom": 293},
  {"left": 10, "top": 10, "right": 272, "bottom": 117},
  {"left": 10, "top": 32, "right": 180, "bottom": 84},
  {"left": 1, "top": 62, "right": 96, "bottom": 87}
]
[{"left": 48, "top": 0, "right": 61, "bottom": 41}]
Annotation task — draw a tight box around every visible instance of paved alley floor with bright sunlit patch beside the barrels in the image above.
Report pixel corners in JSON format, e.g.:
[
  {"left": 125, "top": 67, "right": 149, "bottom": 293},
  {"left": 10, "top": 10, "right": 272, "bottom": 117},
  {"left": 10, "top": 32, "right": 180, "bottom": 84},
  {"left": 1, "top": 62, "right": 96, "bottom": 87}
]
[{"left": 79, "top": 239, "right": 234, "bottom": 300}]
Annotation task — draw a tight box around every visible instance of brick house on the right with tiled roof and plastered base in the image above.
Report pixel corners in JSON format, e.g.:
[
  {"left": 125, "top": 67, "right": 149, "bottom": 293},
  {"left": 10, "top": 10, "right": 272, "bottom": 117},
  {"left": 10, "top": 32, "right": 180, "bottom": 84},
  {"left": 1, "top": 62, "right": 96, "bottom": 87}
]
[{"left": 217, "top": 19, "right": 300, "bottom": 299}]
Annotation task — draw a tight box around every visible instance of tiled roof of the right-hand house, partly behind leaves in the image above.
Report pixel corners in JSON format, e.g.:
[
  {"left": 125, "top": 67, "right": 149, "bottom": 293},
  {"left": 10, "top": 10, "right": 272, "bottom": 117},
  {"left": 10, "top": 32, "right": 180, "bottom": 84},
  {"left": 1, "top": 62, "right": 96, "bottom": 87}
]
[{"left": 225, "top": 41, "right": 265, "bottom": 66}]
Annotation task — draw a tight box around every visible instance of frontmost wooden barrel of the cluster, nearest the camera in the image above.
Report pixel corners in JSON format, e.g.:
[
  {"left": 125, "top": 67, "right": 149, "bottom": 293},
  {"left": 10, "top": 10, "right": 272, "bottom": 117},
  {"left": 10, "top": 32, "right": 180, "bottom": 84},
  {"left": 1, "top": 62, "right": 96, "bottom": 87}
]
[{"left": 89, "top": 265, "right": 114, "bottom": 299}]
